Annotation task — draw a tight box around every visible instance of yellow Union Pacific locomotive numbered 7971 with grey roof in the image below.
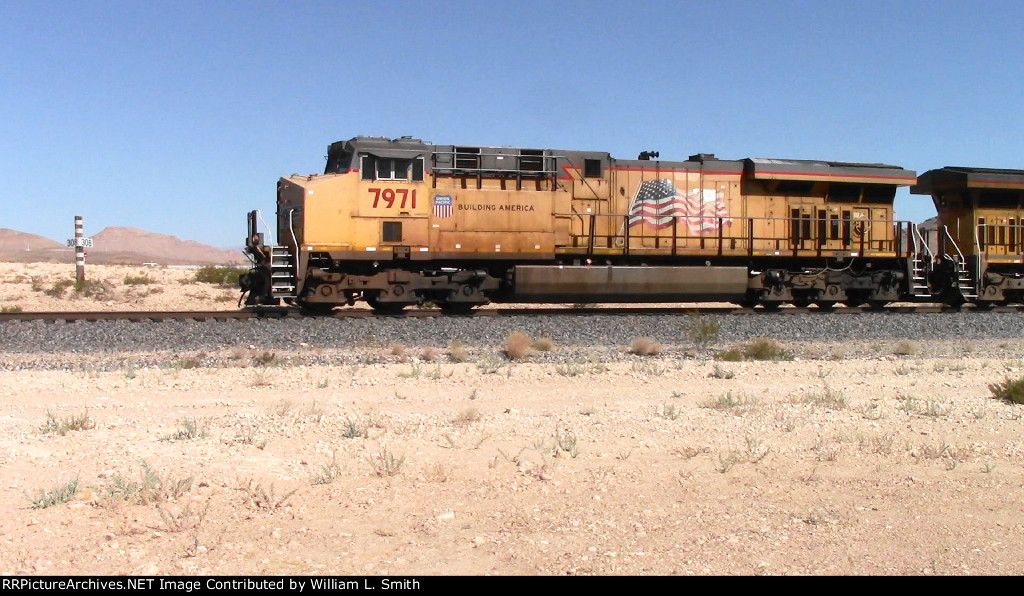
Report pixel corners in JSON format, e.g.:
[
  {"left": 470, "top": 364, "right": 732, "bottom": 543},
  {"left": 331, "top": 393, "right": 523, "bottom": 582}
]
[{"left": 242, "top": 137, "right": 942, "bottom": 311}]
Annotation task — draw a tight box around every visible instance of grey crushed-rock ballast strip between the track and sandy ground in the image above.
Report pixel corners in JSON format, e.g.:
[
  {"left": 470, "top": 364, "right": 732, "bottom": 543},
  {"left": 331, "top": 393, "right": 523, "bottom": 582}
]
[{"left": 0, "top": 312, "right": 1022, "bottom": 364}]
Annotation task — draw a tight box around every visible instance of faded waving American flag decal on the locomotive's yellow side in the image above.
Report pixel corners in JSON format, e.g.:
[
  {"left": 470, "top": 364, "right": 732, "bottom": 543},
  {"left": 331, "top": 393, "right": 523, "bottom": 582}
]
[{"left": 629, "top": 178, "right": 732, "bottom": 236}]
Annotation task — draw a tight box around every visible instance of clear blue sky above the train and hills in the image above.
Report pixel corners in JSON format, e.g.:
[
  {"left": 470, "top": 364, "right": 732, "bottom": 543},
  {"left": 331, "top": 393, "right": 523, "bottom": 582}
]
[{"left": 0, "top": 0, "right": 1024, "bottom": 247}]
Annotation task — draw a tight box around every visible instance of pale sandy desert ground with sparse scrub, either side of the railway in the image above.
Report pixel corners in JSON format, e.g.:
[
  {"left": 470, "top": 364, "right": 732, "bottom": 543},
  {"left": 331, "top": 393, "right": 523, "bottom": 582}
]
[{"left": 0, "top": 263, "right": 1024, "bottom": 576}]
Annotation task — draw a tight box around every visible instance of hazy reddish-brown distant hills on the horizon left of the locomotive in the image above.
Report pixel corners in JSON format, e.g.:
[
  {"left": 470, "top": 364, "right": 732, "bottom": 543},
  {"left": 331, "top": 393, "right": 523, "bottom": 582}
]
[{"left": 0, "top": 227, "right": 248, "bottom": 265}]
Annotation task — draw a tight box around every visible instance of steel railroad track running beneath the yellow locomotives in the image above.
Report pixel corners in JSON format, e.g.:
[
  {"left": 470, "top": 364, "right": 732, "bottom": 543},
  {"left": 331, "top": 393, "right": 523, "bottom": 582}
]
[{"left": 0, "top": 304, "right": 1011, "bottom": 323}]
